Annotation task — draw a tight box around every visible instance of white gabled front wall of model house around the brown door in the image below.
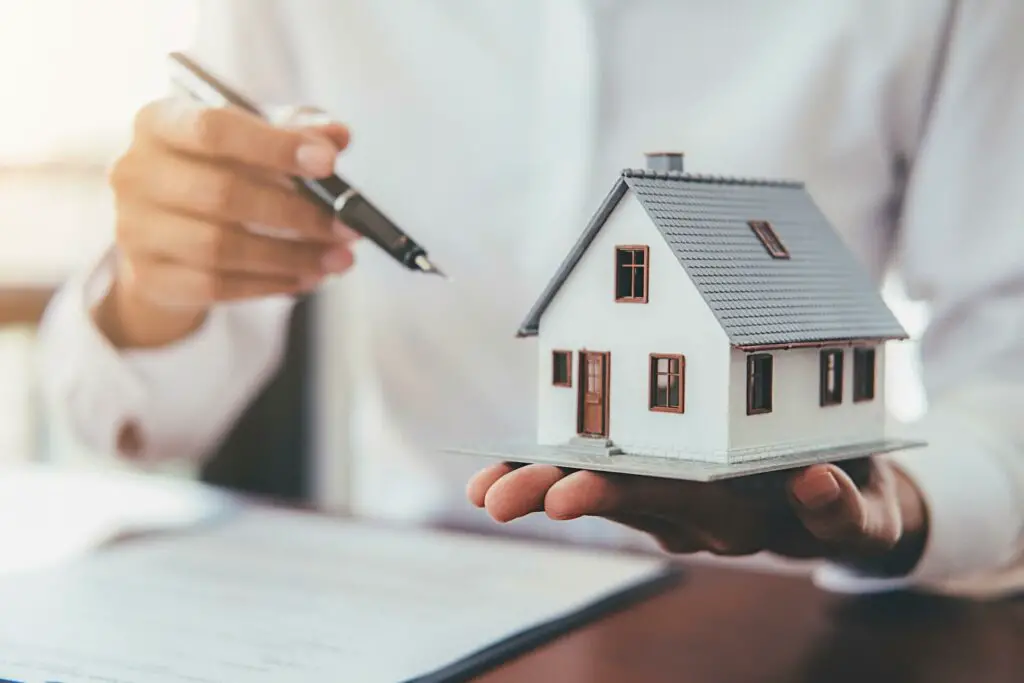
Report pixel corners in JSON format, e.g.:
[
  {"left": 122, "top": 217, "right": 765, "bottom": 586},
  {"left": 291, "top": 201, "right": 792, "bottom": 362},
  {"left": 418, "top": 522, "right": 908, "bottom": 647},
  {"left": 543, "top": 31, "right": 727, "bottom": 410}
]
[{"left": 538, "top": 193, "right": 729, "bottom": 462}]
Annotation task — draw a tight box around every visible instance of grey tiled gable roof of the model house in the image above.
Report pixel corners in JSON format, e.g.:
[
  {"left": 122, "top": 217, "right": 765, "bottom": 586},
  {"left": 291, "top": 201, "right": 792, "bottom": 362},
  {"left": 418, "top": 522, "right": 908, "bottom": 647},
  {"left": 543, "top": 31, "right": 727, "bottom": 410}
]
[{"left": 518, "top": 169, "right": 907, "bottom": 347}]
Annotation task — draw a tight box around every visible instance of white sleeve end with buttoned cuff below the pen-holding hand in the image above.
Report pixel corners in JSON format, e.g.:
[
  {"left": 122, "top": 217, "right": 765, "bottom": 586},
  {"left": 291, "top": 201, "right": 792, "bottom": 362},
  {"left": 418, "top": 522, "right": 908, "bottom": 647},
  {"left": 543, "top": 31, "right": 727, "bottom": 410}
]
[{"left": 40, "top": 251, "right": 292, "bottom": 462}]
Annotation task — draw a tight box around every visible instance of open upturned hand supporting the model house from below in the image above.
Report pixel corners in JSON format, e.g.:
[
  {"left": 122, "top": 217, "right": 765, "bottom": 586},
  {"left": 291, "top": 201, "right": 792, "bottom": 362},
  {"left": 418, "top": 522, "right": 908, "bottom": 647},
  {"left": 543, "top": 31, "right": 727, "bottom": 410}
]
[{"left": 467, "top": 459, "right": 928, "bottom": 575}]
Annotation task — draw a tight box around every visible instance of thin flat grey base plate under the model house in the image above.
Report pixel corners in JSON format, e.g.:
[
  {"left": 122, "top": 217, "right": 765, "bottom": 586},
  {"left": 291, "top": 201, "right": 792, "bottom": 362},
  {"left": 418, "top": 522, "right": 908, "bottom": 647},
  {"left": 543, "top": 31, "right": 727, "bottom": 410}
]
[{"left": 445, "top": 439, "right": 926, "bottom": 481}]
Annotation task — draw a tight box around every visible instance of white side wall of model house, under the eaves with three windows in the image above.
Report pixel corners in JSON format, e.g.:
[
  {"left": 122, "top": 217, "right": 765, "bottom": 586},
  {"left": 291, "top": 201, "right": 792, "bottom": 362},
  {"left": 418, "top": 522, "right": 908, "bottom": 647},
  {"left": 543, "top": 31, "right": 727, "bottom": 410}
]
[{"left": 729, "top": 345, "right": 885, "bottom": 462}]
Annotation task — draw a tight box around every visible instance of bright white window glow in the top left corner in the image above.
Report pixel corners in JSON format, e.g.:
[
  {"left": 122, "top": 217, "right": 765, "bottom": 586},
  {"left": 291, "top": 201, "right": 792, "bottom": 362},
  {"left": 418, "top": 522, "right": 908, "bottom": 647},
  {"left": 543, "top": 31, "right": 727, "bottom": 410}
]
[{"left": 0, "top": 0, "right": 195, "bottom": 167}]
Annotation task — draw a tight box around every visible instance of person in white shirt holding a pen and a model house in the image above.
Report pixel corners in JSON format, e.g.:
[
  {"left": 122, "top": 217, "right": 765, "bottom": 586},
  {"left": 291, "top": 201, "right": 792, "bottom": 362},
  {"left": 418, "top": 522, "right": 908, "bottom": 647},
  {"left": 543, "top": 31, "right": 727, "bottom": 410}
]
[{"left": 36, "top": 0, "right": 1024, "bottom": 592}]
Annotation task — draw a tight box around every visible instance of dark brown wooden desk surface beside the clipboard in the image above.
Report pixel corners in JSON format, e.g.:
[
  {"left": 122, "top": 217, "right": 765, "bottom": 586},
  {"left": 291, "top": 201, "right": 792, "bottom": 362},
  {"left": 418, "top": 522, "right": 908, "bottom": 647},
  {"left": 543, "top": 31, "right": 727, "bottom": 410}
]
[{"left": 478, "top": 566, "right": 1024, "bottom": 683}]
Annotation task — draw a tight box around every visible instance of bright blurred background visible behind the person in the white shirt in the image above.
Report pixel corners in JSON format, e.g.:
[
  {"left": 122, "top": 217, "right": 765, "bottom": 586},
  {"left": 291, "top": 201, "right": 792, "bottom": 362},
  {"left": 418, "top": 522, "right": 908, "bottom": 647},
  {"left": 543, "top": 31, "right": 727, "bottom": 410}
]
[{"left": 0, "top": 0, "right": 926, "bottom": 471}]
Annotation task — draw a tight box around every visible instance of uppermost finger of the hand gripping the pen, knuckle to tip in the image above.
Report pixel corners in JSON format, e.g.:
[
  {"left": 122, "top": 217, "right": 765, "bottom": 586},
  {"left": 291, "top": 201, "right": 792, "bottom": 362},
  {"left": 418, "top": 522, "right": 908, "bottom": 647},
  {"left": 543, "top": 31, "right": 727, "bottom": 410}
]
[{"left": 135, "top": 98, "right": 347, "bottom": 177}]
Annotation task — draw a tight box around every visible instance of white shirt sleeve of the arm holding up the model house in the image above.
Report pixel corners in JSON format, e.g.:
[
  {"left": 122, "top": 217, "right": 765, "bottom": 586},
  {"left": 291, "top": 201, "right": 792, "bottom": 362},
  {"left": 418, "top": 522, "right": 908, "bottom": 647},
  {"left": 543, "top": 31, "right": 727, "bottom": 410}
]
[{"left": 818, "top": 0, "right": 1024, "bottom": 595}]
